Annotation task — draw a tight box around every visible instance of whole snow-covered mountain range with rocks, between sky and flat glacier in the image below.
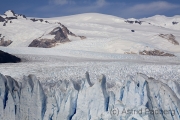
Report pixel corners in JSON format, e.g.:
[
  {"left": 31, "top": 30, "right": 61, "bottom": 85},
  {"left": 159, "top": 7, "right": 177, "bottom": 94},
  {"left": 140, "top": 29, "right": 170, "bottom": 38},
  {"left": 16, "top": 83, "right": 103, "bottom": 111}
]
[{"left": 0, "top": 10, "right": 180, "bottom": 56}]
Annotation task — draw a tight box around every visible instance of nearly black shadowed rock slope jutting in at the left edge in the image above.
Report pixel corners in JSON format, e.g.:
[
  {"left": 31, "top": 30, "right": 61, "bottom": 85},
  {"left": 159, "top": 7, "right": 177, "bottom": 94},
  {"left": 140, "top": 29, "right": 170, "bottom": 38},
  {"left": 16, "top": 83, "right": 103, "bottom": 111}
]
[{"left": 0, "top": 50, "right": 21, "bottom": 63}]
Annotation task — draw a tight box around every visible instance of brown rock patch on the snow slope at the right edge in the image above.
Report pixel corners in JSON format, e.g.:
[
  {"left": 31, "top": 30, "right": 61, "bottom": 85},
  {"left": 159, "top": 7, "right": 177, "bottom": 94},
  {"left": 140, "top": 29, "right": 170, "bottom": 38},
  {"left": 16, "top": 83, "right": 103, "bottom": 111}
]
[{"left": 159, "top": 34, "right": 179, "bottom": 45}]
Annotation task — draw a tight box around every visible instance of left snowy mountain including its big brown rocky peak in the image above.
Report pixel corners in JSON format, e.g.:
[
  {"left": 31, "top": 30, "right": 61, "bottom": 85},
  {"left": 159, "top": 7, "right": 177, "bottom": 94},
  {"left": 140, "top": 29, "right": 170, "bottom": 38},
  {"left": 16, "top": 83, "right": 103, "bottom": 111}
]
[{"left": 0, "top": 10, "right": 86, "bottom": 48}]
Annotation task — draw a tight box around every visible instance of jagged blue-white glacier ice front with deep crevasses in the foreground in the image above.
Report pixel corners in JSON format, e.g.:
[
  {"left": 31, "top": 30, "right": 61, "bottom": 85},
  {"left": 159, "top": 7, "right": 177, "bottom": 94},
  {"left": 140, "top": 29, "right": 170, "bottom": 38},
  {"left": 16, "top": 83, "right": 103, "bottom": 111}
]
[{"left": 0, "top": 72, "right": 180, "bottom": 120}]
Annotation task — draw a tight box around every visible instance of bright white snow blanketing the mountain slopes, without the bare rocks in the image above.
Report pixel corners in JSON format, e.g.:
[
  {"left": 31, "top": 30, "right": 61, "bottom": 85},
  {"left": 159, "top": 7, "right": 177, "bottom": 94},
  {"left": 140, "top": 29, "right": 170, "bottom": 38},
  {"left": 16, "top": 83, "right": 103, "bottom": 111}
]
[{"left": 0, "top": 12, "right": 180, "bottom": 54}]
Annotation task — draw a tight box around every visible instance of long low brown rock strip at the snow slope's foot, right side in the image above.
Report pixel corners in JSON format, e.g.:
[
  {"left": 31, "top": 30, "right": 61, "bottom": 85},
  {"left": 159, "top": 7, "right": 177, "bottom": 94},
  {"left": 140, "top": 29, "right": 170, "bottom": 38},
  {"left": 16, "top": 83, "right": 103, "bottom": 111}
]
[{"left": 139, "top": 50, "right": 175, "bottom": 57}]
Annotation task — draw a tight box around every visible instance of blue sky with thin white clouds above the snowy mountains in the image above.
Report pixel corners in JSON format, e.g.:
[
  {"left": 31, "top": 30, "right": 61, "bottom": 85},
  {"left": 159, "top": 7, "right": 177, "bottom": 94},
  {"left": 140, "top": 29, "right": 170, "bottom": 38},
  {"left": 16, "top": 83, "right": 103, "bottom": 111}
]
[{"left": 0, "top": 0, "right": 180, "bottom": 18}]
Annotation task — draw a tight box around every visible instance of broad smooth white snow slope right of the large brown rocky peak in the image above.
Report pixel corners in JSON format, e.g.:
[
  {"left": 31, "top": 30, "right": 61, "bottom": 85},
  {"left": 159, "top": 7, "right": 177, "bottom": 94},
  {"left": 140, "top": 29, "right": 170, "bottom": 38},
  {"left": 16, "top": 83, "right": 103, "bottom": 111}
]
[{"left": 45, "top": 13, "right": 180, "bottom": 53}]
